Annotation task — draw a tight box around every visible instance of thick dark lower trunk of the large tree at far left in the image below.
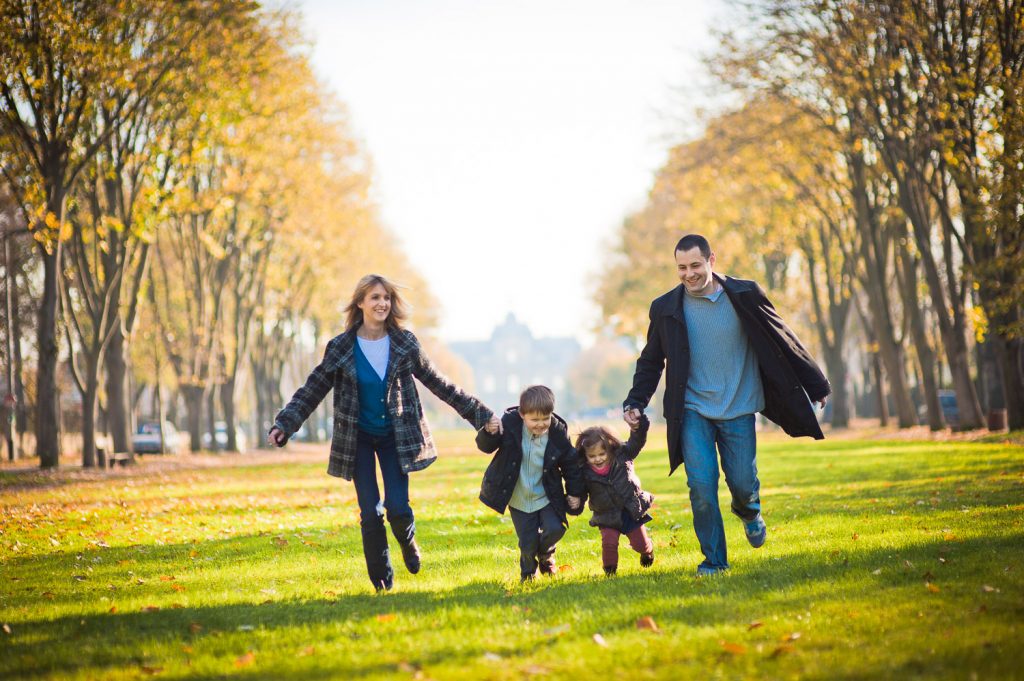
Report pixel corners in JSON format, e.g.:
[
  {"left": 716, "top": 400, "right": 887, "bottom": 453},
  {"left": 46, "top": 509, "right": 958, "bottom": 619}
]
[{"left": 36, "top": 244, "right": 60, "bottom": 468}]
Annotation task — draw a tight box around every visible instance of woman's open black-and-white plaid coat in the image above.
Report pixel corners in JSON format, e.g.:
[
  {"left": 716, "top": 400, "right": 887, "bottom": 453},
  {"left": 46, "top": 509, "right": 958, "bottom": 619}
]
[{"left": 274, "top": 329, "right": 492, "bottom": 480}]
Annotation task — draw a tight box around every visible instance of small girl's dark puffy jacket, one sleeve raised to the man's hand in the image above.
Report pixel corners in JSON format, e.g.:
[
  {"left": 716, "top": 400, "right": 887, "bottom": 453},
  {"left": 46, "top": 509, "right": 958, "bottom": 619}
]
[{"left": 579, "top": 417, "right": 654, "bottom": 529}]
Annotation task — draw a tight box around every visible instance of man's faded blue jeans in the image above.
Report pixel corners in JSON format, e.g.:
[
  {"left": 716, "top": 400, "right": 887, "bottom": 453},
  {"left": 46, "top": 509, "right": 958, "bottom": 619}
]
[{"left": 682, "top": 410, "right": 761, "bottom": 568}]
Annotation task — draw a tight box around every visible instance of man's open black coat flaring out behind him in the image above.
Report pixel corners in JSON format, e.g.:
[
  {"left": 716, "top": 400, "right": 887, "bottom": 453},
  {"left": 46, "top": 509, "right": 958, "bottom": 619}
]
[{"left": 623, "top": 274, "right": 831, "bottom": 475}]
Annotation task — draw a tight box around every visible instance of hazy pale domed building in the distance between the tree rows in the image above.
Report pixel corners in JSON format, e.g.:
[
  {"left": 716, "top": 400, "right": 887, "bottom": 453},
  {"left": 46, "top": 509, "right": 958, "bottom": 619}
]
[{"left": 449, "top": 312, "right": 581, "bottom": 410}]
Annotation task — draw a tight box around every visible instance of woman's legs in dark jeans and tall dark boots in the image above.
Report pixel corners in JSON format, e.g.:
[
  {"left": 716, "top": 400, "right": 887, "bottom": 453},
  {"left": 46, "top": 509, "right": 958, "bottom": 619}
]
[{"left": 353, "top": 430, "right": 420, "bottom": 591}]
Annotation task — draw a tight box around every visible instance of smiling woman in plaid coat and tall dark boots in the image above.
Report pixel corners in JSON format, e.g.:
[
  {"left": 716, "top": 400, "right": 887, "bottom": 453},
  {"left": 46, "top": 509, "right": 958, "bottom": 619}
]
[{"left": 269, "top": 274, "right": 500, "bottom": 591}]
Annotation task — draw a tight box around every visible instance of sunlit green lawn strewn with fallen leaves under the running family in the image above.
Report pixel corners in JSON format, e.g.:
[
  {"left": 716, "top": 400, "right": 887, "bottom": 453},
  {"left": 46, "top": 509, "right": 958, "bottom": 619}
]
[{"left": 0, "top": 432, "right": 1024, "bottom": 681}]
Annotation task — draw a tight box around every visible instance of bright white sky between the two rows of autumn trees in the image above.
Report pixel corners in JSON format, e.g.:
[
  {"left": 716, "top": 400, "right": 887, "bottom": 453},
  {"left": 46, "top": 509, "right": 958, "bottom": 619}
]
[{"left": 296, "top": 0, "right": 719, "bottom": 345}]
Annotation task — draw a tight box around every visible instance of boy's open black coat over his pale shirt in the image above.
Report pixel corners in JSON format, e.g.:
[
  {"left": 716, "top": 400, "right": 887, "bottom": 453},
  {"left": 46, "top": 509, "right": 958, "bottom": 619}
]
[{"left": 476, "top": 407, "right": 586, "bottom": 524}]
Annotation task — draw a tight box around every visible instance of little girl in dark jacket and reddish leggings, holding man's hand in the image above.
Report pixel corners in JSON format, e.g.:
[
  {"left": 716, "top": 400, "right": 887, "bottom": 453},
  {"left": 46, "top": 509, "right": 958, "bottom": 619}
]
[{"left": 577, "top": 416, "right": 654, "bottom": 574}]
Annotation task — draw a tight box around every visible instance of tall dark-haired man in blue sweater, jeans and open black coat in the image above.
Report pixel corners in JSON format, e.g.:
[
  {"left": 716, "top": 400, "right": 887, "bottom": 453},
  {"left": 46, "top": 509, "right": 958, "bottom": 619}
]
[{"left": 623, "top": 235, "right": 831, "bottom": 577}]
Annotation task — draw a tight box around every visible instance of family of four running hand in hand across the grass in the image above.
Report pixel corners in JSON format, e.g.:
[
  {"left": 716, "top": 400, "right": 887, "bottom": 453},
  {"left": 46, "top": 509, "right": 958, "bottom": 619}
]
[{"left": 268, "top": 235, "right": 829, "bottom": 591}]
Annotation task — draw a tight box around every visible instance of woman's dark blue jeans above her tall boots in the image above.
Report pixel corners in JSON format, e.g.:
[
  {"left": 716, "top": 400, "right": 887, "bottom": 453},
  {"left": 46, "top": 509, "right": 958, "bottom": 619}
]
[{"left": 352, "top": 430, "right": 413, "bottom": 526}]
